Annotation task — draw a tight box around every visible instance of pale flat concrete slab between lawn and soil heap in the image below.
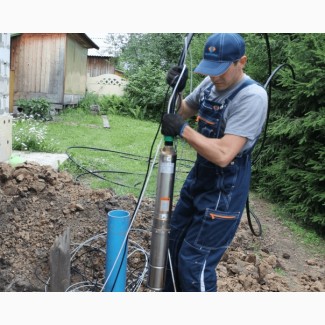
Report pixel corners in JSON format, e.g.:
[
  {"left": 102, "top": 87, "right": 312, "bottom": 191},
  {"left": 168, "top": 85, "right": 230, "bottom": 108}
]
[{"left": 7, "top": 150, "right": 69, "bottom": 170}]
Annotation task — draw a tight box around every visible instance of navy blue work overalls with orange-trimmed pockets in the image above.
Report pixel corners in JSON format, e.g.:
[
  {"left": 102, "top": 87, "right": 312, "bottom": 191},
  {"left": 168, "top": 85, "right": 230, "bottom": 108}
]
[{"left": 164, "top": 79, "right": 260, "bottom": 292}]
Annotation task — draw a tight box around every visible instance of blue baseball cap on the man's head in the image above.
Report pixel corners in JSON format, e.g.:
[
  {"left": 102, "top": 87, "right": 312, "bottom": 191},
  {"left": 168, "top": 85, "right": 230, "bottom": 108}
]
[{"left": 194, "top": 33, "right": 245, "bottom": 76}]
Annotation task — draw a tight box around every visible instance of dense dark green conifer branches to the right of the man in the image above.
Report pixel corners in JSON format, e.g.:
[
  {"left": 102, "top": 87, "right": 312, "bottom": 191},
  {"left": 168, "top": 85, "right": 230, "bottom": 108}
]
[{"left": 252, "top": 34, "right": 325, "bottom": 232}]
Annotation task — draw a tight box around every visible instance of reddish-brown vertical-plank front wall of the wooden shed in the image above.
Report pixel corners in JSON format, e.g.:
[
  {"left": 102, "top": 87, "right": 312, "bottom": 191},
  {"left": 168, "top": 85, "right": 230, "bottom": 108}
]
[{"left": 11, "top": 33, "right": 66, "bottom": 103}]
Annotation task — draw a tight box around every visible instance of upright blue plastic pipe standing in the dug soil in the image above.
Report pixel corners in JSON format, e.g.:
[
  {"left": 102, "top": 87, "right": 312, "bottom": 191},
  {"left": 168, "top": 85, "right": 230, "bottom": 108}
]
[{"left": 103, "top": 210, "right": 130, "bottom": 292}]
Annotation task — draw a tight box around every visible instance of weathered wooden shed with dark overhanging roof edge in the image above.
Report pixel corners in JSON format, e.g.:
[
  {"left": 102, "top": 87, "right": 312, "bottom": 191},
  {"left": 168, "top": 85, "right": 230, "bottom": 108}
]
[{"left": 10, "top": 33, "right": 99, "bottom": 112}]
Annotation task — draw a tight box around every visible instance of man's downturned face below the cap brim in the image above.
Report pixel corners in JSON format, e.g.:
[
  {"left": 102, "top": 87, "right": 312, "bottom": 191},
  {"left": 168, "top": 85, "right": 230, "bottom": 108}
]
[{"left": 210, "top": 57, "right": 246, "bottom": 91}]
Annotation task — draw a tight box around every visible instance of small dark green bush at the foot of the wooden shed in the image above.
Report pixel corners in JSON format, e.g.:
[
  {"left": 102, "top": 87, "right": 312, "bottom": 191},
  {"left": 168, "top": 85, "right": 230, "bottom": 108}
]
[{"left": 16, "top": 97, "right": 52, "bottom": 120}]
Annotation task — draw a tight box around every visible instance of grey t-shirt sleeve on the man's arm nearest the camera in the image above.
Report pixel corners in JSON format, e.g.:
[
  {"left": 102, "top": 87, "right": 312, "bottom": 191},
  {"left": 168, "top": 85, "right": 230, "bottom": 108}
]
[{"left": 225, "top": 85, "right": 267, "bottom": 141}]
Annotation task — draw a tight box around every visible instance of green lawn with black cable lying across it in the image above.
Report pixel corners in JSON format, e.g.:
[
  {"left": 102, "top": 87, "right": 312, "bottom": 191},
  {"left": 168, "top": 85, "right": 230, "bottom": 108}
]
[{"left": 47, "top": 109, "right": 194, "bottom": 197}]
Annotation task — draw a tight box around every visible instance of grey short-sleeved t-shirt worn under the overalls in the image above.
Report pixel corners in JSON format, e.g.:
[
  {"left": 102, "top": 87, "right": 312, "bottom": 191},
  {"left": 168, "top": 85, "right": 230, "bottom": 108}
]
[{"left": 185, "top": 74, "right": 268, "bottom": 152}]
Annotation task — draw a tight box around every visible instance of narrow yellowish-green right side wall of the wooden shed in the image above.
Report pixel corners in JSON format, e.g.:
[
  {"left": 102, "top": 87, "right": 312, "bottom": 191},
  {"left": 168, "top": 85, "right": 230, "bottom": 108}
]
[{"left": 64, "top": 37, "right": 88, "bottom": 105}]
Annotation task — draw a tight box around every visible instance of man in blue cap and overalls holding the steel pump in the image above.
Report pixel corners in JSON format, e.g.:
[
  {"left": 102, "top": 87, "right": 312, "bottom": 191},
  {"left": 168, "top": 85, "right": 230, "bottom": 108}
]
[{"left": 161, "top": 34, "right": 268, "bottom": 292}]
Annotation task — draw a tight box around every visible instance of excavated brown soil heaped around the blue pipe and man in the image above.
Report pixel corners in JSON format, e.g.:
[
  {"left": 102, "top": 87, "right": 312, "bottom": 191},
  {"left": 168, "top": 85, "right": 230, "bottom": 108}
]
[{"left": 0, "top": 163, "right": 325, "bottom": 292}]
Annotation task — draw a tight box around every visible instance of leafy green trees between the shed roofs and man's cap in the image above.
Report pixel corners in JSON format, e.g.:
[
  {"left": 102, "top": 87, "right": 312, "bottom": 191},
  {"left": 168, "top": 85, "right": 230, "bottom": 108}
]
[{"left": 119, "top": 33, "right": 207, "bottom": 121}]
